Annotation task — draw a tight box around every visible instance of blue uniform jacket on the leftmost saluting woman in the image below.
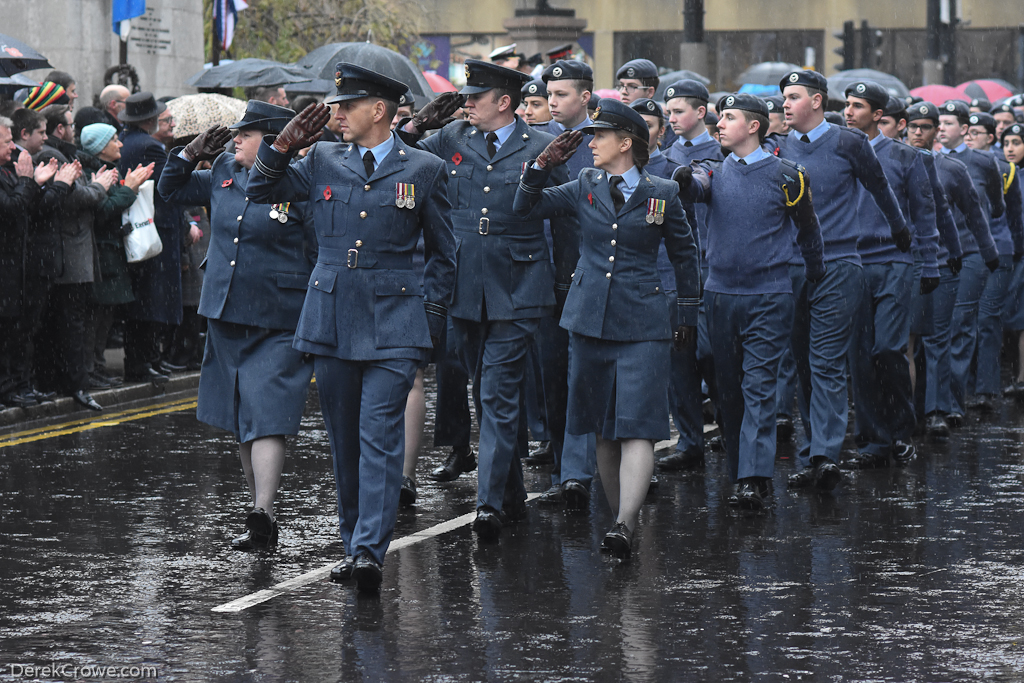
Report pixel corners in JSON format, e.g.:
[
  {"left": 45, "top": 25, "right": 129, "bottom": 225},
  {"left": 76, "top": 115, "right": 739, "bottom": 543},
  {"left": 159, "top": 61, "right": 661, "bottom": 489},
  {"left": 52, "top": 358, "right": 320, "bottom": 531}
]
[{"left": 158, "top": 147, "right": 316, "bottom": 330}]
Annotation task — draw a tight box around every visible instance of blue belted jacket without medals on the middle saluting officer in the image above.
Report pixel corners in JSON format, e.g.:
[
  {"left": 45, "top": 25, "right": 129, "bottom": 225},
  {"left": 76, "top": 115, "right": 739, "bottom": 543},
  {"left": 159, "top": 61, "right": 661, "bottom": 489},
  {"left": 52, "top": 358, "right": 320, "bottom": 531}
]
[{"left": 409, "top": 117, "right": 580, "bottom": 322}]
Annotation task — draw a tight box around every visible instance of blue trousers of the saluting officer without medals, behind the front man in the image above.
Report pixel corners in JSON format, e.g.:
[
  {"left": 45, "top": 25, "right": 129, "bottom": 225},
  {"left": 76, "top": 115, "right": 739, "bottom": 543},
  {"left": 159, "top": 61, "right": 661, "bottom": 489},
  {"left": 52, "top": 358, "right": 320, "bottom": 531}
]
[{"left": 452, "top": 317, "right": 539, "bottom": 510}]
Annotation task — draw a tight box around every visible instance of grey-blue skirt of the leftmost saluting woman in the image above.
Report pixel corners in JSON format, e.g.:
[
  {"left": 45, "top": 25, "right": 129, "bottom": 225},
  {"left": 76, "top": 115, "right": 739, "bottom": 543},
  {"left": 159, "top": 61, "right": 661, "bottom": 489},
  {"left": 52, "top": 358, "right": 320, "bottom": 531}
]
[{"left": 196, "top": 319, "right": 313, "bottom": 443}]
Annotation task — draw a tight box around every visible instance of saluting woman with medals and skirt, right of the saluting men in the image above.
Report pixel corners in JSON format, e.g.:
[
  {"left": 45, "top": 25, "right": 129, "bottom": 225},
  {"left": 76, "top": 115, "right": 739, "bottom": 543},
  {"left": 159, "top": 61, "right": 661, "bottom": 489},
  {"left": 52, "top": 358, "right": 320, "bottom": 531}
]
[{"left": 513, "top": 99, "right": 700, "bottom": 558}]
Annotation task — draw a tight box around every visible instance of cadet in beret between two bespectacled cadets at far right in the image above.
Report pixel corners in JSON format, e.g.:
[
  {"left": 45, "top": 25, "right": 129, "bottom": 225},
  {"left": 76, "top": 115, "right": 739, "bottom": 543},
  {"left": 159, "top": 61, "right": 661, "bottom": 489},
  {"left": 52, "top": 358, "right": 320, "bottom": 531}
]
[{"left": 938, "top": 99, "right": 1014, "bottom": 427}]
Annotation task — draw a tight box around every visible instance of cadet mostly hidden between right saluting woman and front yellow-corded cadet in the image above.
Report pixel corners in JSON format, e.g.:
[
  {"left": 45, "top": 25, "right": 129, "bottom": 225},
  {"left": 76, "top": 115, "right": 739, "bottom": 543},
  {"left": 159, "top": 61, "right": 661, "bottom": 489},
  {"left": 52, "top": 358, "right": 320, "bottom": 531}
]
[{"left": 657, "top": 79, "right": 725, "bottom": 471}]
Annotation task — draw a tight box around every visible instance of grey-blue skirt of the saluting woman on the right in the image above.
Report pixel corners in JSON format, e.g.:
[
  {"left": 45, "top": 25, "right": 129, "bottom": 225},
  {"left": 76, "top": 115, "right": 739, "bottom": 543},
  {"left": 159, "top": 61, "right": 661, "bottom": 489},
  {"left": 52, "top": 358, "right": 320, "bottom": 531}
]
[{"left": 566, "top": 334, "right": 672, "bottom": 440}]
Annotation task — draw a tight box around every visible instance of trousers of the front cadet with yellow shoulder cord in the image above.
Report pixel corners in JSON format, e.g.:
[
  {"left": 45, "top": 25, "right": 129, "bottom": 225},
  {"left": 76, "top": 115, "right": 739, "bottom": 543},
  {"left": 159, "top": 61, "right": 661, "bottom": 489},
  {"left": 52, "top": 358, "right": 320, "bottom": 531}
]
[{"left": 705, "top": 292, "right": 794, "bottom": 481}]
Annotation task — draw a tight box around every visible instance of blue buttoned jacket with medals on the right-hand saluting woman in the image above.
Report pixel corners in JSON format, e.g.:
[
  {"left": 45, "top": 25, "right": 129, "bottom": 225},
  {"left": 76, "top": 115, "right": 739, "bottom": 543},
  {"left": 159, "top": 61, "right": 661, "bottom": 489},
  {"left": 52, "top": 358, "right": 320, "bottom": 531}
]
[{"left": 513, "top": 163, "right": 700, "bottom": 341}]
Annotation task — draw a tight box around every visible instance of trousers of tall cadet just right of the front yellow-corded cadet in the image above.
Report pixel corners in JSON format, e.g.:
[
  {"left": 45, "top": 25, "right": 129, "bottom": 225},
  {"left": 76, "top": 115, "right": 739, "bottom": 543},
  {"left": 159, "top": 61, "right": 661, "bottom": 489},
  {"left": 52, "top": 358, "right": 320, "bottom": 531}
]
[{"left": 790, "top": 261, "right": 863, "bottom": 467}]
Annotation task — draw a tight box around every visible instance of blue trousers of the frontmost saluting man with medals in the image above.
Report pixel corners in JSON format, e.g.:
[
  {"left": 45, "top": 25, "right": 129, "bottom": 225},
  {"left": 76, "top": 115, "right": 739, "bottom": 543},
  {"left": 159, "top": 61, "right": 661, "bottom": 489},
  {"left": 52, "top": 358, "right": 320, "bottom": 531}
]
[{"left": 313, "top": 356, "right": 420, "bottom": 564}]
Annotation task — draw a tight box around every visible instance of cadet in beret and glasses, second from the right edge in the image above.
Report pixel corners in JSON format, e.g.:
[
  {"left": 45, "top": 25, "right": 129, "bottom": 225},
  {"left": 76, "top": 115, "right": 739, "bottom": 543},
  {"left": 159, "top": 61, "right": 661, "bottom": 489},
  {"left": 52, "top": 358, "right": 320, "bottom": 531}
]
[{"left": 967, "top": 113, "right": 1024, "bottom": 412}]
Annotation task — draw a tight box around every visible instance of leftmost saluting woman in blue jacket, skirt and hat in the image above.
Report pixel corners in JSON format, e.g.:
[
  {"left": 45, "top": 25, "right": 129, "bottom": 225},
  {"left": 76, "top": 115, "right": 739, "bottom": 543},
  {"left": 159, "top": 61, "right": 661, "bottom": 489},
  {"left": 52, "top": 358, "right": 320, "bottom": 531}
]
[{"left": 159, "top": 100, "right": 316, "bottom": 550}]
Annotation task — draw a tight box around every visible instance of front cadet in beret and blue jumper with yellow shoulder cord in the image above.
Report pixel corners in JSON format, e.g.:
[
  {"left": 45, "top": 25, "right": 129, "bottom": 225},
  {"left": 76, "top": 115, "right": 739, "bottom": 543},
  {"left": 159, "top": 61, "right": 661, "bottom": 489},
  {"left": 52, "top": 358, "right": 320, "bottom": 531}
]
[{"left": 676, "top": 94, "right": 825, "bottom": 511}]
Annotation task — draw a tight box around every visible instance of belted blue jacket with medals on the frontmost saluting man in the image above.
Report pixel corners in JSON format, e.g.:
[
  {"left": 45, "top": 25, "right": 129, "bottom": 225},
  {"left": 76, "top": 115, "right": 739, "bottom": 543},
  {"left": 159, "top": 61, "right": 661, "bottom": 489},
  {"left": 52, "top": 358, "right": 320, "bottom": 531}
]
[{"left": 247, "top": 132, "right": 455, "bottom": 360}]
